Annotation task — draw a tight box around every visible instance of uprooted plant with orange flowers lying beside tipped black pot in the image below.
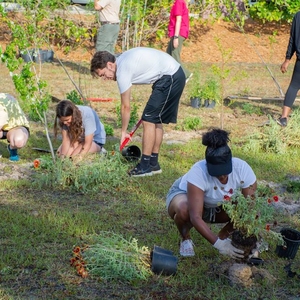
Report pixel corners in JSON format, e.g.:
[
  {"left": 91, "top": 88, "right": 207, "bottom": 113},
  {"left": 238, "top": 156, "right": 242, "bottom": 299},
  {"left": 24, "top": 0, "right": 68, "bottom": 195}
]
[{"left": 71, "top": 231, "right": 152, "bottom": 282}]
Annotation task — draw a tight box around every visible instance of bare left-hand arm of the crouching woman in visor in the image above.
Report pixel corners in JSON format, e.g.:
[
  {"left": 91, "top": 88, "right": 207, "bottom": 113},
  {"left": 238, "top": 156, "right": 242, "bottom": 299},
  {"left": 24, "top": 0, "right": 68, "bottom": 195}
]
[{"left": 187, "top": 182, "right": 218, "bottom": 245}]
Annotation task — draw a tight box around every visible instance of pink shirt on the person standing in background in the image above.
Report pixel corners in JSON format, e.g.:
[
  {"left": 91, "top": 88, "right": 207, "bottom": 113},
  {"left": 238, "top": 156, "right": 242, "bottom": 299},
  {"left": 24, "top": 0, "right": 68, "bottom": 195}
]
[{"left": 168, "top": 0, "right": 190, "bottom": 38}]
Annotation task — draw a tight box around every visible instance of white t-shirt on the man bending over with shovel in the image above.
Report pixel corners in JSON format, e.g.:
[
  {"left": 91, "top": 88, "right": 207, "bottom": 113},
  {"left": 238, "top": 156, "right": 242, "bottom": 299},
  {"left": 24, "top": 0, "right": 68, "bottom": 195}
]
[{"left": 116, "top": 47, "right": 180, "bottom": 94}]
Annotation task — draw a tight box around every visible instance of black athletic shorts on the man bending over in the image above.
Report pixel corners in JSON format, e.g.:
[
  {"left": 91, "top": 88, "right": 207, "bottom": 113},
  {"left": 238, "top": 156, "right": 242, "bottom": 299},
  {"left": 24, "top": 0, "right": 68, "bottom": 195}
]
[{"left": 142, "top": 67, "right": 186, "bottom": 124}]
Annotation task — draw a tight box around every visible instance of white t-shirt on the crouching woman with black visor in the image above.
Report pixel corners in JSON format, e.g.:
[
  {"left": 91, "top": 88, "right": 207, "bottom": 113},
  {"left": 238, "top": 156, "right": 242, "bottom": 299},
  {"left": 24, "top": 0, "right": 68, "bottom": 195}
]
[{"left": 179, "top": 157, "right": 256, "bottom": 207}]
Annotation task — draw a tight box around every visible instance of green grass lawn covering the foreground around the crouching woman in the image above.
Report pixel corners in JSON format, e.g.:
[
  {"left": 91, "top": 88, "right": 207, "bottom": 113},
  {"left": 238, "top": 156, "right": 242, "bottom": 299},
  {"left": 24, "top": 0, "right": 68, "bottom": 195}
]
[{"left": 0, "top": 125, "right": 300, "bottom": 299}]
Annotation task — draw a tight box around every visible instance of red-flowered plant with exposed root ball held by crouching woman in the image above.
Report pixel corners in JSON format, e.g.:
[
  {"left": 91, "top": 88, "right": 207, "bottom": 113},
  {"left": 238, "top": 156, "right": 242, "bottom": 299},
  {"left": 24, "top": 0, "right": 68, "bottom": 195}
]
[{"left": 222, "top": 185, "right": 284, "bottom": 258}]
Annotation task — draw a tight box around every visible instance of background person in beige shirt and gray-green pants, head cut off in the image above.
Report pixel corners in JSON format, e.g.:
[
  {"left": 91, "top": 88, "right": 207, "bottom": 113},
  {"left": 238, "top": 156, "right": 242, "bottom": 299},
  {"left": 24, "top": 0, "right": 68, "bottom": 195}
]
[{"left": 94, "top": 0, "right": 121, "bottom": 53}]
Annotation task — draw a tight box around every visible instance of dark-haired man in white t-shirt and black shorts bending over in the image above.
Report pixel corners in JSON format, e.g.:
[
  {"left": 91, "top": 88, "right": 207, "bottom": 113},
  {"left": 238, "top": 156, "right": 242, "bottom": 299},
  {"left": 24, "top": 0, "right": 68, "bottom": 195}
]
[{"left": 91, "top": 47, "right": 185, "bottom": 177}]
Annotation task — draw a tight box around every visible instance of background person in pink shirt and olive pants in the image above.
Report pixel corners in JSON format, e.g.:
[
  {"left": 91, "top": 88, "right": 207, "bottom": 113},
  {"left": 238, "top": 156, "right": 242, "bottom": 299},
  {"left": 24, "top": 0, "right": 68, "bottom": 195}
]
[{"left": 167, "top": 0, "right": 193, "bottom": 82}]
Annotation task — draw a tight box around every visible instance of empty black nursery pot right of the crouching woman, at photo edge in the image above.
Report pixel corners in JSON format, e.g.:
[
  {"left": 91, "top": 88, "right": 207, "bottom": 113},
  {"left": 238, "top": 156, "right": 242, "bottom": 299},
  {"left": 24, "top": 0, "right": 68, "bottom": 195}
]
[{"left": 276, "top": 228, "right": 300, "bottom": 259}]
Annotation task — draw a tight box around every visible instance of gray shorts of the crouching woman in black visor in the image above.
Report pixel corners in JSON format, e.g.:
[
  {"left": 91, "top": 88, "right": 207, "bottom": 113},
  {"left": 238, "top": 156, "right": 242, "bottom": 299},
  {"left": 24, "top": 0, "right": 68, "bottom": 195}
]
[{"left": 166, "top": 178, "right": 222, "bottom": 223}]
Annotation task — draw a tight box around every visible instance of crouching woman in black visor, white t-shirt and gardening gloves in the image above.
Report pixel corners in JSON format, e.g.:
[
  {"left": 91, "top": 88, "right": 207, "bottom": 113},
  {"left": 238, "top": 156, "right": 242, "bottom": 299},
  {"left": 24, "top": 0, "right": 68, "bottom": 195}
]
[{"left": 166, "top": 129, "right": 257, "bottom": 258}]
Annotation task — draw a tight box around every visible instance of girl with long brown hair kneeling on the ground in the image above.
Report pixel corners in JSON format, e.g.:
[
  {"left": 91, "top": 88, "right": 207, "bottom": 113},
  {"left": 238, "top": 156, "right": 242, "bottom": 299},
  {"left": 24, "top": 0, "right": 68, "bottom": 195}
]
[{"left": 54, "top": 100, "right": 106, "bottom": 158}]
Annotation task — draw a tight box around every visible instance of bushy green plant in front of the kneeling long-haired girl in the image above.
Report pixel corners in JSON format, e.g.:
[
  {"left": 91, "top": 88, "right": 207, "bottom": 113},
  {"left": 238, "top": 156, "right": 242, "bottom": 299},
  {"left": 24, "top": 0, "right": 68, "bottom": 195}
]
[{"left": 34, "top": 146, "right": 130, "bottom": 193}]
